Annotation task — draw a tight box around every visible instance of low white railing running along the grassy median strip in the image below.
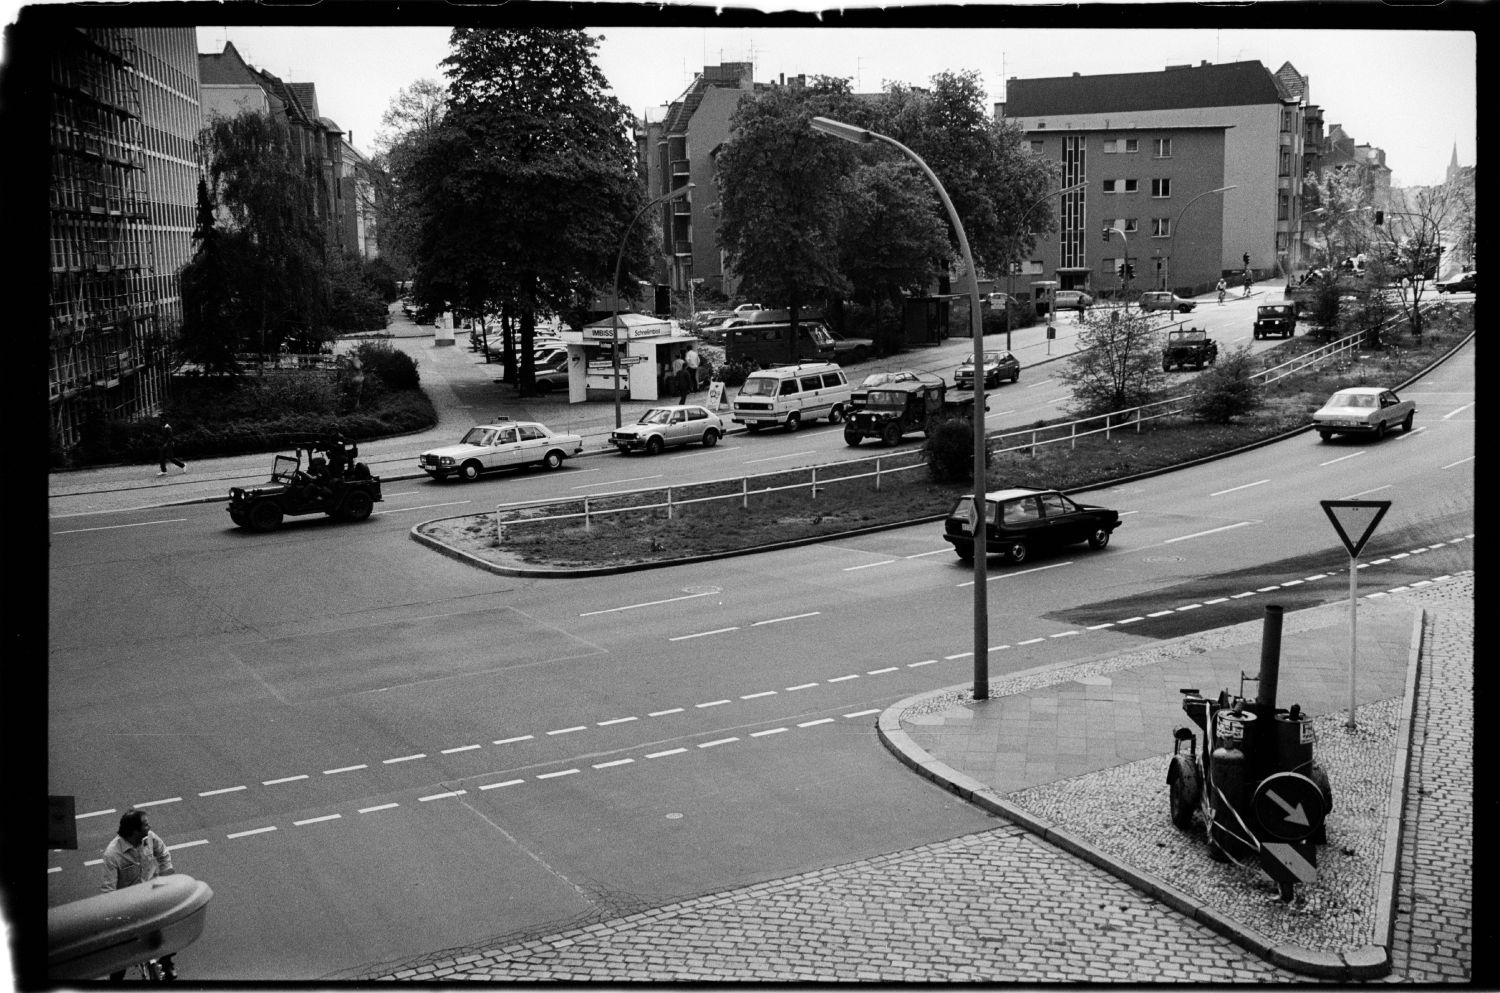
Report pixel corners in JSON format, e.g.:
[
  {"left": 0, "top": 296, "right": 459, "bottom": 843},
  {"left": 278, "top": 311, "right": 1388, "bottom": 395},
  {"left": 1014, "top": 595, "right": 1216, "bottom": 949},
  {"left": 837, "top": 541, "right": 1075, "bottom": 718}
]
[{"left": 495, "top": 318, "right": 1428, "bottom": 542}]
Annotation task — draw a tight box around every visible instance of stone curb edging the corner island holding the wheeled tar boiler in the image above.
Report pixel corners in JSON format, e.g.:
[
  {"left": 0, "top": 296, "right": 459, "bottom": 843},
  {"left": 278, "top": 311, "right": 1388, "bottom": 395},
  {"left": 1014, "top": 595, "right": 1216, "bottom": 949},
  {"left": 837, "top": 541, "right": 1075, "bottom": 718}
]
[{"left": 876, "top": 608, "right": 1427, "bottom": 983}]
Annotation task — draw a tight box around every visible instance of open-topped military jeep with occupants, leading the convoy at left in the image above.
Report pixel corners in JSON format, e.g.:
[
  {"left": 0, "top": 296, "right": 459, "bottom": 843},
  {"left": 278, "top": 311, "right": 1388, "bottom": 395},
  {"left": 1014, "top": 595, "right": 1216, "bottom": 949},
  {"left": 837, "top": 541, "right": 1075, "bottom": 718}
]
[{"left": 225, "top": 441, "right": 381, "bottom": 531}]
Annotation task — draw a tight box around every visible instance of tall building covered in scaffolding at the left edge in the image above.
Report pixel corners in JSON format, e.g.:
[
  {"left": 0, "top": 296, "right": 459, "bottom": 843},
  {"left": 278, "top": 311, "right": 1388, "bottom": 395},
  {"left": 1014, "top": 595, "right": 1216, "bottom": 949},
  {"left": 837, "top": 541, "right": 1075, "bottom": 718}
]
[{"left": 39, "top": 26, "right": 200, "bottom": 452}]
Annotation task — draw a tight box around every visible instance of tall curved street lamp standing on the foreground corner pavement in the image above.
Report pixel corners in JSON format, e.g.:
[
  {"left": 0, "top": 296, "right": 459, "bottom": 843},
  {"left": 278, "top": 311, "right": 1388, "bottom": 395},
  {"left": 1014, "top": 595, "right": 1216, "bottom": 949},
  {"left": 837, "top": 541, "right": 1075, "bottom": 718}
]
[{"left": 812, "top": 117, "right": 990, "bottom": 701}]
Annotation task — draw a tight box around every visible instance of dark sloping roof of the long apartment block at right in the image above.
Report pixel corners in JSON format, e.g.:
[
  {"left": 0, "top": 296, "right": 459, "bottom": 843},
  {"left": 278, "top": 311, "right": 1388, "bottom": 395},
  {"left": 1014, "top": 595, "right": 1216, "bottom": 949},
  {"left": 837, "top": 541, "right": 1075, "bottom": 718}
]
[{"left": 1005, "top": 62, "right": 1284, "bottom": 117}]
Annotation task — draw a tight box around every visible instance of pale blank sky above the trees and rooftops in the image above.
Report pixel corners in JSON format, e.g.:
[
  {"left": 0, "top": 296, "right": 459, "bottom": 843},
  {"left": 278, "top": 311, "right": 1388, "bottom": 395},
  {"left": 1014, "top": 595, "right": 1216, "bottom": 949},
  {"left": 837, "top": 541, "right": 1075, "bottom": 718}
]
[{"left": 178, "top": 24, "right": 1478, "bottom": 185}]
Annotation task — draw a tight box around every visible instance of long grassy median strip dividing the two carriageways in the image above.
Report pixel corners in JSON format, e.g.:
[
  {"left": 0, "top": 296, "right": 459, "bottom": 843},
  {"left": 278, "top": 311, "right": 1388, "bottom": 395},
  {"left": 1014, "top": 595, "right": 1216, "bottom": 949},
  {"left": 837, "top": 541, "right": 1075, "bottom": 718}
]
[{"left": 419, "top": 309, "right": 1473, "bottom": 569}]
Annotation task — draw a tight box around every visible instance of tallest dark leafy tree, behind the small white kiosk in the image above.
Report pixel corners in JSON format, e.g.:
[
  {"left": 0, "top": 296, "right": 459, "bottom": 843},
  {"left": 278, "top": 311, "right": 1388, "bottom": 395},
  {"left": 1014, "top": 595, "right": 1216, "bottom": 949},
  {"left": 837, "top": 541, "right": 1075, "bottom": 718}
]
[{"left": 393, "top": 27, "right": 647, "bottom": 392}]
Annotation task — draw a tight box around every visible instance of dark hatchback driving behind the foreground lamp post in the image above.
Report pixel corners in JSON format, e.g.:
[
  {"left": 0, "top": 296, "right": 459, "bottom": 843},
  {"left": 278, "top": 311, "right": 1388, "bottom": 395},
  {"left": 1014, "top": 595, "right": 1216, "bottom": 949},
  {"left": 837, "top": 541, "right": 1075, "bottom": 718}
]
[{"left": 944, "top": 489, "right": 1121, "bottom": 564}]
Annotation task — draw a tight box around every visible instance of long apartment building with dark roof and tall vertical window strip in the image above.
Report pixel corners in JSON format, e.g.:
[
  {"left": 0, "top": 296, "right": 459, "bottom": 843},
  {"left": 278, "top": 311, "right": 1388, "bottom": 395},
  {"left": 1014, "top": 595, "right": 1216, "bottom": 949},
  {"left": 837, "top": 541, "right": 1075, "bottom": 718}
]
[{"left": 996, "top": 62, "right": 1308, "bottom": 294}]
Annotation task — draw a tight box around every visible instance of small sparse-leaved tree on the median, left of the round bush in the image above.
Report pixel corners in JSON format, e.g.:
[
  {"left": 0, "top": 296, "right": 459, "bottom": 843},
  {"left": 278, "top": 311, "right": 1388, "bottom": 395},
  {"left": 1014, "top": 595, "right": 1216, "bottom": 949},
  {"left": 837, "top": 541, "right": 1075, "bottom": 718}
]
[{"left": 1059, "top": 312, "right": 1166, "bottom": 416}]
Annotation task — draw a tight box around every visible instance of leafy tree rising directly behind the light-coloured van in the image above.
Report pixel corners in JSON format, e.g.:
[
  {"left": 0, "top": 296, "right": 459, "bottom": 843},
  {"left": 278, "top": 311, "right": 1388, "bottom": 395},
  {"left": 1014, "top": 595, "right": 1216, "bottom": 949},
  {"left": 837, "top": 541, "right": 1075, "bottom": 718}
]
[{"left": 714, "top": 77, "right": 857, "bottom": 360}]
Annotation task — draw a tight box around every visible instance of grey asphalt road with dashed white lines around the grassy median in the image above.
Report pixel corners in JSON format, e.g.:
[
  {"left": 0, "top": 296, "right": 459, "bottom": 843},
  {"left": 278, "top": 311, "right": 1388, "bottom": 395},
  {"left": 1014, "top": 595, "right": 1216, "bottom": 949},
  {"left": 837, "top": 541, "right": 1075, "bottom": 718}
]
[{"left": 48, "top": 330, "right": 1475, "bottom": 980}]
